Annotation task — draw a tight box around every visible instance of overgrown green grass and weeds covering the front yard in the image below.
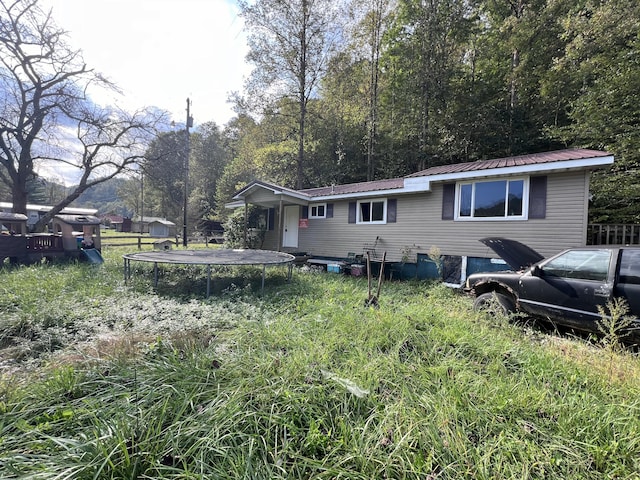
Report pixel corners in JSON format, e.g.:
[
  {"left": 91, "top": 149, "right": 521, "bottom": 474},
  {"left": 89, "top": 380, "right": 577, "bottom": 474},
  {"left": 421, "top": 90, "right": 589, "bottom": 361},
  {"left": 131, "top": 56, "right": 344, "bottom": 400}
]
[{"left": 0, "top": 250, "right": 640, "bottom": 479}]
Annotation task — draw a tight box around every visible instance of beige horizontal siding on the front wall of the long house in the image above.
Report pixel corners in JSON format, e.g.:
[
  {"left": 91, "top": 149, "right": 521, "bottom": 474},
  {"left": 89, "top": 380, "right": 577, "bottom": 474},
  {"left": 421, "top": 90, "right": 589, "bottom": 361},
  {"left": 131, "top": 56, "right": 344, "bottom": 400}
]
[{"left": 265, "top": 172, "right": 589, "bottom": 262}]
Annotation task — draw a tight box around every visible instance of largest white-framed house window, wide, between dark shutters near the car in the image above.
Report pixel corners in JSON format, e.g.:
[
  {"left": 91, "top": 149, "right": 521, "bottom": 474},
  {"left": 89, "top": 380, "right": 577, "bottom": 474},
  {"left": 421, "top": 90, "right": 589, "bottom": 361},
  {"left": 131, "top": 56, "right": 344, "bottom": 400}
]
[{"left": 456, "top": 178, "right": 529, "bottom": 220}]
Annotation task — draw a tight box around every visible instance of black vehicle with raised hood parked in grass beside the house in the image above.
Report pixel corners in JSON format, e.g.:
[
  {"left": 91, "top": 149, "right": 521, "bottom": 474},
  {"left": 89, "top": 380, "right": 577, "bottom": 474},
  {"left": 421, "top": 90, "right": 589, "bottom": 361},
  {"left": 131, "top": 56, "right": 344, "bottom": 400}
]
[{"left": 465, "top": 237, "right": 640, "bottom": 343}]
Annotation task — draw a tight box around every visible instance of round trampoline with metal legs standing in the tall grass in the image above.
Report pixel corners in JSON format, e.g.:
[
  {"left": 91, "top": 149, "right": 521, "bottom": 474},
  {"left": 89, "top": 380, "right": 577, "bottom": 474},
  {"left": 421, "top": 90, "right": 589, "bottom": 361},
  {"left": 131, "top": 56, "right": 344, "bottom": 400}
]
[{"left": 122, "top": 249, "right": 296, "bottom": 298}]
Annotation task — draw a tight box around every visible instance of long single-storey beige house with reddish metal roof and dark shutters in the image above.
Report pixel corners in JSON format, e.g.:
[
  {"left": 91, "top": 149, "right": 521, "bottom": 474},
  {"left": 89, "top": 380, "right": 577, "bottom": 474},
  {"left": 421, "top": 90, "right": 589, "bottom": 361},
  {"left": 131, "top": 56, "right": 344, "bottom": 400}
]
[{"left": 229, "top": 149, "right": 614, "bottom": 283}]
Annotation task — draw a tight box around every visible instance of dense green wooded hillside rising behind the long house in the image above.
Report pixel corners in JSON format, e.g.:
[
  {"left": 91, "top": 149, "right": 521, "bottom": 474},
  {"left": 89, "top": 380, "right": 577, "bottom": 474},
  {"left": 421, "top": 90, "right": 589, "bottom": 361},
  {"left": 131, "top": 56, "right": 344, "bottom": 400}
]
[{"left": 219, "top": 0, "right": 640, "bottom": 221}]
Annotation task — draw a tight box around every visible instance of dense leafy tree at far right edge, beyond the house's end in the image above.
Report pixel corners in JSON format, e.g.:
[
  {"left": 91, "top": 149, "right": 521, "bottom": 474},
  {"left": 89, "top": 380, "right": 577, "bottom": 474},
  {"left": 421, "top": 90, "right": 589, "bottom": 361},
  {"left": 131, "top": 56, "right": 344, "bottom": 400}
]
[{"left": 555, "top": 0, "right": 640, "bottom": 223}]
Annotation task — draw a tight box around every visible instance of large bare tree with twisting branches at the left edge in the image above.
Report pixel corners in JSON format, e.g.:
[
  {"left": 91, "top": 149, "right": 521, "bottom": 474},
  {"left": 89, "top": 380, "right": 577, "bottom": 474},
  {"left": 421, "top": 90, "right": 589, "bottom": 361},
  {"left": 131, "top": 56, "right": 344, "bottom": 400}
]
[{"left": 0, "top": 0, "right": 164, "bottom": 230}]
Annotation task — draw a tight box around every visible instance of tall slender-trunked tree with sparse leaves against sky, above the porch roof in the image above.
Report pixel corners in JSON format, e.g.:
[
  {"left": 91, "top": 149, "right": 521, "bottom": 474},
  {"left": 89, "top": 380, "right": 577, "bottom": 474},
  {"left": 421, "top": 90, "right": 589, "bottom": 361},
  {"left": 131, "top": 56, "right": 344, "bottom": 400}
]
[{"left": 240, "top": 0, "right": 339, "bottom": 188}]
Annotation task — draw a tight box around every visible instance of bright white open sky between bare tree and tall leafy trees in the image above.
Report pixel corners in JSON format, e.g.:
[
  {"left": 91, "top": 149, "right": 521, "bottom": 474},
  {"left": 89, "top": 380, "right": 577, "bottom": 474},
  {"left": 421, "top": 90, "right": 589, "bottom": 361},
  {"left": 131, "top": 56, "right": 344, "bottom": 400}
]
[{"left": 40, "top": 0, "right": 250, "bottom": 127}]
